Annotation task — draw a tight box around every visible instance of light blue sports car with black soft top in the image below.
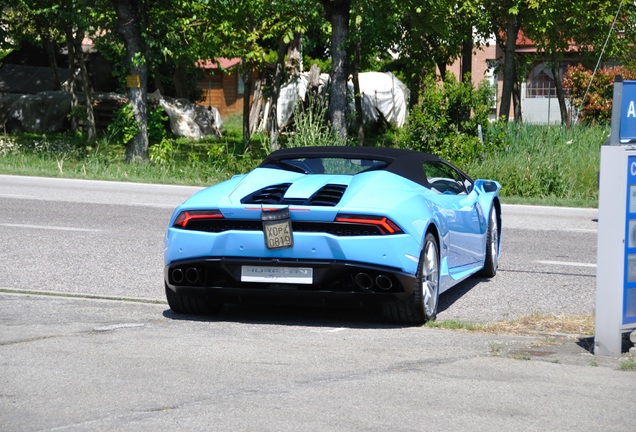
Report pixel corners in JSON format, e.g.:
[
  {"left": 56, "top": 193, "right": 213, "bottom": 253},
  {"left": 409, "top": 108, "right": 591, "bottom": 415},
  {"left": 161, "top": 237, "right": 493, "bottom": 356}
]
[{"left": 164, "top": 146, "right": 501, "bottom": 325}]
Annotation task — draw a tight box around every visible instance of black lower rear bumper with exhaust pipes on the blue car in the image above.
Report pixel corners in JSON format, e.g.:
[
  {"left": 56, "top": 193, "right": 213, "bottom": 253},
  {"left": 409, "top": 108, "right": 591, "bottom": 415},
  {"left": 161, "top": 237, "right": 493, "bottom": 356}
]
[{"left": 164, "top": 257, "right": 417, "bottom": 304}]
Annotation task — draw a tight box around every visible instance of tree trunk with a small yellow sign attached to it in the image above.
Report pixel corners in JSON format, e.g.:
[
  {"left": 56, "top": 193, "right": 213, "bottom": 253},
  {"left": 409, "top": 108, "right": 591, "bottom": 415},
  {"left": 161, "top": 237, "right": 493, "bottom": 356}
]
[{"left": 111, "top": 0, "right": 148, "bottom": 162}]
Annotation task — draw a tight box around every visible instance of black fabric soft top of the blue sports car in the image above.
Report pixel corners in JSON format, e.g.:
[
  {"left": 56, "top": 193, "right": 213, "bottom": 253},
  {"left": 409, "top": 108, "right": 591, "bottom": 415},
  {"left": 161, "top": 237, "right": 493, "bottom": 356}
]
[{"left": 259, "top": 146, "right": 460, "bottom": 185}]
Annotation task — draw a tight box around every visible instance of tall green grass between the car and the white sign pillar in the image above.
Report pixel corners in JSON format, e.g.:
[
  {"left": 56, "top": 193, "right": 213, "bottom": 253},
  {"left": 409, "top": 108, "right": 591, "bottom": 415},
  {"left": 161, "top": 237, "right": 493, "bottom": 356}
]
[{"left": 464, "top": 125, "right": 609, "bottom": 207}]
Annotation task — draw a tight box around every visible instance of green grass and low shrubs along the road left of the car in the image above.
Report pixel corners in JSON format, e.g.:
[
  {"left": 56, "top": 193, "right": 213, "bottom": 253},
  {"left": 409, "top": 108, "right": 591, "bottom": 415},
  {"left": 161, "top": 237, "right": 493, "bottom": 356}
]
[{"left": 0, "top": 134, "right": 264, "bottom": 186}]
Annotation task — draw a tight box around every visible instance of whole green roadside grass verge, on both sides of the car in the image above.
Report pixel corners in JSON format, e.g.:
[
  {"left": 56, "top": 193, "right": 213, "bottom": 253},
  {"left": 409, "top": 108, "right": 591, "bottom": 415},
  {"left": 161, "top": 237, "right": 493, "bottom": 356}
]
[{"left": 0, "top": 117, "right": 608, "bottom": 207}]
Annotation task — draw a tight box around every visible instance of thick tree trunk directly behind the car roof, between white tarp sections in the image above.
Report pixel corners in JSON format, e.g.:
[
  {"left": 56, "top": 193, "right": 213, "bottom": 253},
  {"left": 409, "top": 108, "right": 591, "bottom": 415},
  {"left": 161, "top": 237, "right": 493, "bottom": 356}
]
[{"left": 322, "top": 0, "right": 351, "bottom": 140}]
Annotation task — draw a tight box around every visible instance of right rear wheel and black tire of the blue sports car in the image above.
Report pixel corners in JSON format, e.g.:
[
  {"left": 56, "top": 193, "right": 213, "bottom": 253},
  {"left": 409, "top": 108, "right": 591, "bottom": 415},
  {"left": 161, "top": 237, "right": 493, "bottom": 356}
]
[{"left": 382, "top": 233, "right": 440, "bottom": 325}]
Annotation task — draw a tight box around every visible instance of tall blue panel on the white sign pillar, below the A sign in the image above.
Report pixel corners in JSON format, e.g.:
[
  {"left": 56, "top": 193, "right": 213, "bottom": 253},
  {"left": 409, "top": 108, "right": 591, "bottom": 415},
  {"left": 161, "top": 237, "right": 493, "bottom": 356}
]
[{"left": 623, "top": 156, "right": 636, "bottom": 324}]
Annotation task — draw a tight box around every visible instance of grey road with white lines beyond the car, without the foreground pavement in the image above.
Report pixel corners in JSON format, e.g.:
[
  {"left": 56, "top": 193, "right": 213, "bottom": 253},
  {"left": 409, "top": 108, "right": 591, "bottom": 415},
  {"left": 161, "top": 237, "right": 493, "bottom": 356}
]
[{"left": 0, "top": 176, "right": 597, "bottom": 322}]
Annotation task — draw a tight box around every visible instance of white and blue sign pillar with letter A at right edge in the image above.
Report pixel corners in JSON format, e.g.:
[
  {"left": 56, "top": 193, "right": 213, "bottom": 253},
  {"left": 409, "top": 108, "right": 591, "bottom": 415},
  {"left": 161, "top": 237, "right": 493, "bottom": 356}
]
[{"left": 594, "top": 76, "right": 636, "bottom": 356}]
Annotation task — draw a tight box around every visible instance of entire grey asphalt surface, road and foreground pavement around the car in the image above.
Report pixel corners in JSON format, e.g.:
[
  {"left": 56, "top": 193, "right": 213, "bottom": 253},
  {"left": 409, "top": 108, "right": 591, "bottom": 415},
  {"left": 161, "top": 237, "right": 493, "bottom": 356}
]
[{"left": 0, "top": 176, "right": 636, "bottom": 431}]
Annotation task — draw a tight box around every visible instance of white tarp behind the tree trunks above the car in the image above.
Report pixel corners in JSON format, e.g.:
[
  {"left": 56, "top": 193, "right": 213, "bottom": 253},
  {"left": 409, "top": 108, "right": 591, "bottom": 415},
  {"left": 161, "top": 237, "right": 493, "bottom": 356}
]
[{"left": 277, "top": 72, "right": 409, "bottom": 127}]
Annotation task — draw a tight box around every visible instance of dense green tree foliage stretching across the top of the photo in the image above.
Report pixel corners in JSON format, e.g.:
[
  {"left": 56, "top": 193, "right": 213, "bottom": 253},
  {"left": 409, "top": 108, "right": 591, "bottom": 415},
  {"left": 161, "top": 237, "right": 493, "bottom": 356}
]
[{"left": 0, "top": 0, "right": 636, "bottom": 154}]
